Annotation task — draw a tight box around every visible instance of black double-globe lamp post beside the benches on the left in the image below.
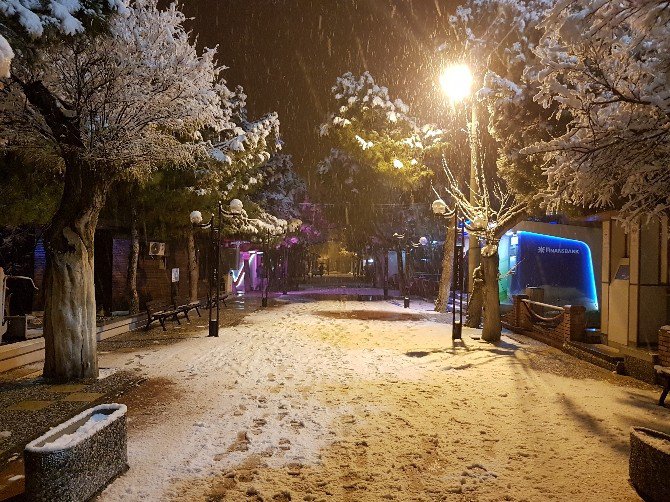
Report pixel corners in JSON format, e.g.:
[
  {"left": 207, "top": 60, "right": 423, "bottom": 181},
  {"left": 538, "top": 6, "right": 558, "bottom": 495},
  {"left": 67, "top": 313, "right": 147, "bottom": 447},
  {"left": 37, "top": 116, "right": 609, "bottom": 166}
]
[{"left": 190, "top": 199, "right": 244, "bottom": 337}]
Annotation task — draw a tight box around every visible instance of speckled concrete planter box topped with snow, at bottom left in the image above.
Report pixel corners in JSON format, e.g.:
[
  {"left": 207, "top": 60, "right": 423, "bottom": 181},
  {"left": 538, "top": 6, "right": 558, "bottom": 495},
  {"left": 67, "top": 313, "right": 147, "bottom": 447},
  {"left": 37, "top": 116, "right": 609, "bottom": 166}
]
[{"left": 24, "top": 404, "right": 128, "bottom": 502}]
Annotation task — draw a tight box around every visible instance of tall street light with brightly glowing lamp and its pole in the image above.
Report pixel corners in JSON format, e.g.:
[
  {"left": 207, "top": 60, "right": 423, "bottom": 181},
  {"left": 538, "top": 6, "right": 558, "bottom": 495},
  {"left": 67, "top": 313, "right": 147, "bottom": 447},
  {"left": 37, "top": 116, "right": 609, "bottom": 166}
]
[{"left": 439, "top": 64, "right": 481, "bottom": 298}]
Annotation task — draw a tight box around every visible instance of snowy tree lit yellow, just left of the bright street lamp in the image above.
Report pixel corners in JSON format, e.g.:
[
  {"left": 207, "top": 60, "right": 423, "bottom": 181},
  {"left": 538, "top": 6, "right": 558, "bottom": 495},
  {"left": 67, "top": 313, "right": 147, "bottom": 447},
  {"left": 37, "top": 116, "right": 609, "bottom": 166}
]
[{"left": 317, "top": 72, "right": 449, "bottom": 294}]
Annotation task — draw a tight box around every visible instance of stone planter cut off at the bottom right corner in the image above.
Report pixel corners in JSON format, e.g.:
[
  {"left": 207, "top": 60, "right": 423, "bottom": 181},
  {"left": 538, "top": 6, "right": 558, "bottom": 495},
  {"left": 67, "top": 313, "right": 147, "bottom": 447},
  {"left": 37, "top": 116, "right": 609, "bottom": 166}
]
[{"left": 629, "top": 427, "right": 670, "bottom": 502}]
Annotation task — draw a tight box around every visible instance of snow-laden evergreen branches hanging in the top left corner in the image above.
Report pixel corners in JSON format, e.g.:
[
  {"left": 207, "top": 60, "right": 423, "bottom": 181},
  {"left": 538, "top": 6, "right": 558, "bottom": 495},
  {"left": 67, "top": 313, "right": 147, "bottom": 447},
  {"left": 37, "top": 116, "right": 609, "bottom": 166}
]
[{"left": 0, "top": 0, "right": 127, "bottom": 78}]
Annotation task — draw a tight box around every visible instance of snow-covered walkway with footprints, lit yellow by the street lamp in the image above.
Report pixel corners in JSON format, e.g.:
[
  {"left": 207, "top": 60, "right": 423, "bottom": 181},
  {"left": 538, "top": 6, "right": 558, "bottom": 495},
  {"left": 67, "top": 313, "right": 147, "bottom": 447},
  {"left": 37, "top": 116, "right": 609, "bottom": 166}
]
[{"left": 100, "top": 301, "right": 670, "bottom": 501}]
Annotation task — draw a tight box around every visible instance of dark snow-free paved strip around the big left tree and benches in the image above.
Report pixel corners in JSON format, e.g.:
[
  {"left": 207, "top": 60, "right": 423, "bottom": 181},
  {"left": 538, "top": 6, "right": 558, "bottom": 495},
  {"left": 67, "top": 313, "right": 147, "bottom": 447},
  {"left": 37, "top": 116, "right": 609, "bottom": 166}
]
[{"left": 0, "top": 296, "right": 266, "bottom": 500}]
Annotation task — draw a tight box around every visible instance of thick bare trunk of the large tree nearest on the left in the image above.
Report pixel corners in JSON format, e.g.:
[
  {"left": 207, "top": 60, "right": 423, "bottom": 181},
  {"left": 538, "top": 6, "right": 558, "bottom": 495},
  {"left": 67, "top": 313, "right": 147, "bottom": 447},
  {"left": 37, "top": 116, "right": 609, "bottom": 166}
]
[{"left": 44, "top": 158, "right": 109, "bottom": 382}]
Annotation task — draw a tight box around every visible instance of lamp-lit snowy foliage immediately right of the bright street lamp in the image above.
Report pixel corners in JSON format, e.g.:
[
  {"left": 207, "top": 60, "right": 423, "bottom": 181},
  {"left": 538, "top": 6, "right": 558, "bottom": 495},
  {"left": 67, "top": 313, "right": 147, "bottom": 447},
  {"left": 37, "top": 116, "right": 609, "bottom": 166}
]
[{"left": 446, "top": 0, "right": 560, "bottom": 219}]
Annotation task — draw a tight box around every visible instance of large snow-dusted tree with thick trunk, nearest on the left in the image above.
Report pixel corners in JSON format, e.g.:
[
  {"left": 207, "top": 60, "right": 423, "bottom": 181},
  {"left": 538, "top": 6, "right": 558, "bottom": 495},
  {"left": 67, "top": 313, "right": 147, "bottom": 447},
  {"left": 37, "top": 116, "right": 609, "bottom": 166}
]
[{"left": 0, "top": 0, "right": 232, "bottom": 381}]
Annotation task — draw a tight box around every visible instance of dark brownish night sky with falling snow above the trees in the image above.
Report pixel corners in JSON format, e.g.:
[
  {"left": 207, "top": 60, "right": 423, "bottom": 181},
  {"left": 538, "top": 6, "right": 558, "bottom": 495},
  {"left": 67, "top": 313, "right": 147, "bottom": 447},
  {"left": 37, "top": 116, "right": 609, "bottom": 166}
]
[{"left": 182, "top": 0, "right": 458, "bottom": 180}]
